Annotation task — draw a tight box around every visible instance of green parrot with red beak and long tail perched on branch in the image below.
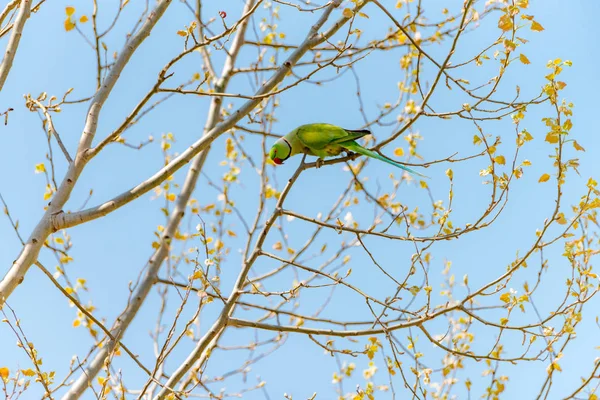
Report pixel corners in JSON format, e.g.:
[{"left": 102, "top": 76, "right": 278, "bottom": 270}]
[{"left": 269, "top": 123, "right": 426, "bottom": 177}]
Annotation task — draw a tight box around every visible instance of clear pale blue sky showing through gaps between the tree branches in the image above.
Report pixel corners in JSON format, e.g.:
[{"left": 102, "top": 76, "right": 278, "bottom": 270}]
[{"left": 0, "top": 0, "right": 600, "bottom": 399}]
